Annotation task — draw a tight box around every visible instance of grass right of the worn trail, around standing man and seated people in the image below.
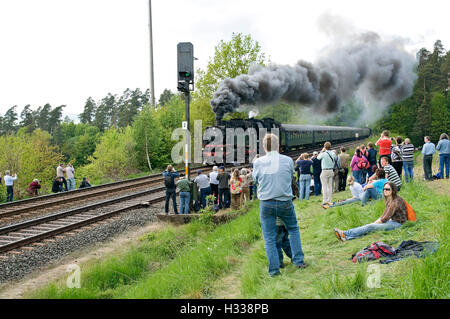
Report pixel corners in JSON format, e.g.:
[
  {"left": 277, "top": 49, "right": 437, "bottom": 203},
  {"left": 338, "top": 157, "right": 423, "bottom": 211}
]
[{"left": 236, "top": 174, "right": 450, "bottom": 298}]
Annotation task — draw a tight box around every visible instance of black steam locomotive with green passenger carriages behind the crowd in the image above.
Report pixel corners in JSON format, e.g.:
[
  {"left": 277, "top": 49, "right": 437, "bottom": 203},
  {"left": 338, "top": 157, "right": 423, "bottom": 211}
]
[{"left": 203, "top": 118, "right": 371, "bottom": 164}]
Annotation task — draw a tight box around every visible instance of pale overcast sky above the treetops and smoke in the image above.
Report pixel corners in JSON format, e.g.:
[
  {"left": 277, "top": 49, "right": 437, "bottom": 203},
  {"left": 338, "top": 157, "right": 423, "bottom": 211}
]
[{"left": 0, "top": 0, "right": 450, "bottom": 118}]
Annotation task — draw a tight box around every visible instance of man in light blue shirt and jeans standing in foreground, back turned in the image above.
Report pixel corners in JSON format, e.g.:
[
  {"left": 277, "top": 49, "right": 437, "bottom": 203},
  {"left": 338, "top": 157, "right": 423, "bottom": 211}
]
[{"left": 252, "top": 134, "right": 307, "bottom": 277}]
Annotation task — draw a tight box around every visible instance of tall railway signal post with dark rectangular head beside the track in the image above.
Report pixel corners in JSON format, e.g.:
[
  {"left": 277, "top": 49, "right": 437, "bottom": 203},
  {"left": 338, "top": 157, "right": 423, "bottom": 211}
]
[{"left": 177, "top": 42, "right": 194, "bottom": 178}]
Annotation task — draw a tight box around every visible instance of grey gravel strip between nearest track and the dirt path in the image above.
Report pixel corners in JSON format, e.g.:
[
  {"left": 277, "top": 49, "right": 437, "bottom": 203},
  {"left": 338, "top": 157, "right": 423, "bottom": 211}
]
[{"left": 0, "top": 207, "right": 161, "bottom": 283}]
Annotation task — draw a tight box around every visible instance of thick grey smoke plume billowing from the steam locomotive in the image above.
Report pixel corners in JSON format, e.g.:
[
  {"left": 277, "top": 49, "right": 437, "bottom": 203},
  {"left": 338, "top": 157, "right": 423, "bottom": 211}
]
[{"left": 211, "top": 16, "right": 416, "bottom": 120}]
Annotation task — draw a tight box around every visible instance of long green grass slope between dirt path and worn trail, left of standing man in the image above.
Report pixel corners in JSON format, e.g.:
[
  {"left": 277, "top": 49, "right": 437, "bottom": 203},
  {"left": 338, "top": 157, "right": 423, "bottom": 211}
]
[{"left": 27, "top": 205, "right": 261, "bottom": 299}]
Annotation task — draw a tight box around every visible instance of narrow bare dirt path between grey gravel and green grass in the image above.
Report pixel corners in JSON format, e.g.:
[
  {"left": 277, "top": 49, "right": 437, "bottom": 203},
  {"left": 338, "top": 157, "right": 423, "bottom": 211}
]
[{"left": 0, "top": 223, "right": 164, "bottom": 299}]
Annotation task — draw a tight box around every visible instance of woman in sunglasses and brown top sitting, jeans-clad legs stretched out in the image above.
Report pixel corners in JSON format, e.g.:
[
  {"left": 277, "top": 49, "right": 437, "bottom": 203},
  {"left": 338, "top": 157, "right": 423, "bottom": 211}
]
[{"left": 334, "top": 182, "right": 408, "bottom": 241}]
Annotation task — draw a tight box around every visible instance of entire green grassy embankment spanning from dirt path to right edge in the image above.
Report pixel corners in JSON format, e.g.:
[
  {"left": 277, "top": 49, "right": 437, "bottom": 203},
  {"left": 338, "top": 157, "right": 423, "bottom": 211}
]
[{"left": 30, "top": 141, "right": 450, "bottom": 298}]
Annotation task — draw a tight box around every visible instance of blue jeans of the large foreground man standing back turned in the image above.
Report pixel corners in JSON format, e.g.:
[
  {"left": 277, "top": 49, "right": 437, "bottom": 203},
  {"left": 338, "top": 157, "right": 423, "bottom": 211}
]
[{"left": 259, "top": 200, "right": 304, "bottom": 276}]
